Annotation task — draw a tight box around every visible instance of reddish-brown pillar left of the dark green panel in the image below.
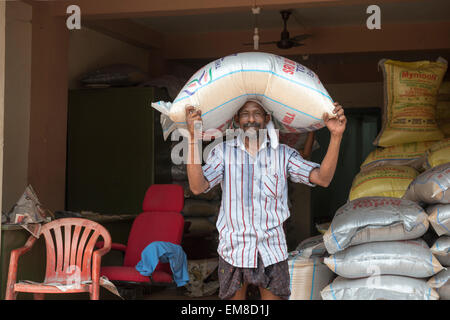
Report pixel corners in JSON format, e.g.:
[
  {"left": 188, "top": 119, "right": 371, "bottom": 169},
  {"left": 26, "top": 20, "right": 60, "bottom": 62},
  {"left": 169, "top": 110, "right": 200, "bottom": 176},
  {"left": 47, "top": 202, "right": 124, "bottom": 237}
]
[{"left": 28, "top": 2, "right": 69, "bottom": 211}]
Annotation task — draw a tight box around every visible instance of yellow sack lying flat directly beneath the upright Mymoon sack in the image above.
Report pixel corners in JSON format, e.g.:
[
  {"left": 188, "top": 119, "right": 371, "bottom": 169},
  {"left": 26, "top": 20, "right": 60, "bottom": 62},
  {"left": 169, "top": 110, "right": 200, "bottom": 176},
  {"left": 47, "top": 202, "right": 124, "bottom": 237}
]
[{"left": 361, "top": 141, "right": 434, "bottom": 171}]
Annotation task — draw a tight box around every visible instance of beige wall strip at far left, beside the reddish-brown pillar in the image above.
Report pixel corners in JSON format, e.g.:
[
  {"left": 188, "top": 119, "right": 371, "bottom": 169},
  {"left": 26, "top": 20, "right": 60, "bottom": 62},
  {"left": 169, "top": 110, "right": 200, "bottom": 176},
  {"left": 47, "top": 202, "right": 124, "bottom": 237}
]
[{"left": 2, "top": 1, "right": 32, "bottom": 212}]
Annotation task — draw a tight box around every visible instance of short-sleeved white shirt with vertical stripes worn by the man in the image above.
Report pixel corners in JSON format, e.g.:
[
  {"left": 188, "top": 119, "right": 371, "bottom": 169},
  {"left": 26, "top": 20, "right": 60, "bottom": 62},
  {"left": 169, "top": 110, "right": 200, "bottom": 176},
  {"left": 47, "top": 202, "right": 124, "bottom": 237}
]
[{"left": 202, "top": 132, "right": 319, "bottom": 268}]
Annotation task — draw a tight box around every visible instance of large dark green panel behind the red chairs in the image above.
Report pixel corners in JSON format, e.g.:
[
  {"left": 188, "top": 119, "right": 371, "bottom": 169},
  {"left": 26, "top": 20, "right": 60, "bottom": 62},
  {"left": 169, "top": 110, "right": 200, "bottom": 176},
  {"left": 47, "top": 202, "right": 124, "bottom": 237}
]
[{"left": 66, "top": 88, "right": 154, "bottom": 214}]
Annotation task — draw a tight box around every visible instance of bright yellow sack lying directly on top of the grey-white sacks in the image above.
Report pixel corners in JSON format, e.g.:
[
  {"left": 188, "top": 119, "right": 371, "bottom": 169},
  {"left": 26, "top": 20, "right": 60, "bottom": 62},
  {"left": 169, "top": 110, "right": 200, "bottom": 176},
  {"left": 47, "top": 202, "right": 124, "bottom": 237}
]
[{"left": 349, "top": 166, "right": 419, "bottom": 201}]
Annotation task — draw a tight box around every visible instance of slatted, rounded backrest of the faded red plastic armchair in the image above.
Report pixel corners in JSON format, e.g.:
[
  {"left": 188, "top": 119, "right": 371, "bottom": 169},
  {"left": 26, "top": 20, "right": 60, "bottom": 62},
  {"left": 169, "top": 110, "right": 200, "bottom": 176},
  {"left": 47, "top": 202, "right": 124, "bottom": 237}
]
[{"left": 40, "top": 218, "right": 111, "bottom": 283}]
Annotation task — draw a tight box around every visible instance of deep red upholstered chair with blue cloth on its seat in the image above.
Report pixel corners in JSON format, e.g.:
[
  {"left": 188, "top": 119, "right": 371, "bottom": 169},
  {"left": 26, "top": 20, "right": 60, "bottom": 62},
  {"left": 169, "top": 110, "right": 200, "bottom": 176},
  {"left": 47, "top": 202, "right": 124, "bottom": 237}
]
[{"left": 98, "top": 184, "right": 184, "bottom": 285}]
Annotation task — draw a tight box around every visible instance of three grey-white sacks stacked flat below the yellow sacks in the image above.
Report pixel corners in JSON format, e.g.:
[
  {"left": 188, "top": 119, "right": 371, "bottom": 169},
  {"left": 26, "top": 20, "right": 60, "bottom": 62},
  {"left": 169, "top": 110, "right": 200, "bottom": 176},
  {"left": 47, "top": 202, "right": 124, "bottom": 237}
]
[{"left": 321, "top": 197, "right": 443, "bottom": 300}]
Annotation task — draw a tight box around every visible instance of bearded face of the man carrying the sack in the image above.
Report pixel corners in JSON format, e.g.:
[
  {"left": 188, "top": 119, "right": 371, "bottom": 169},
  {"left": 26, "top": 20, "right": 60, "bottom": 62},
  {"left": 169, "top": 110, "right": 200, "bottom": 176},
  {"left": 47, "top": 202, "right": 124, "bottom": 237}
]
[{"left": 235, "top": 101, "right": 270, "bottom": 134}]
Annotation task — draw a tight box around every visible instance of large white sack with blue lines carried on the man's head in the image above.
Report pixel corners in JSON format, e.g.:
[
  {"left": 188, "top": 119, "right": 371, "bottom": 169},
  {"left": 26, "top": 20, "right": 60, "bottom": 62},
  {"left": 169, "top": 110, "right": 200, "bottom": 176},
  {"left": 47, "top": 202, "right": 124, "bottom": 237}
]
[{"left": 152, "top": 52, "right": 334, "bottom": 139}]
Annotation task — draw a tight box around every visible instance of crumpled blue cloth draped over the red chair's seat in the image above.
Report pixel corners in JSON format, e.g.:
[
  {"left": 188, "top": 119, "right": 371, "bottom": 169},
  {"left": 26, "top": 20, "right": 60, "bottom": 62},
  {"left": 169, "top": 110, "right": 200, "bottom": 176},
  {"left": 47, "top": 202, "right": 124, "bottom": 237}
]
[{"left": 136, "top": 241, "right": 189, "bottom": 287}]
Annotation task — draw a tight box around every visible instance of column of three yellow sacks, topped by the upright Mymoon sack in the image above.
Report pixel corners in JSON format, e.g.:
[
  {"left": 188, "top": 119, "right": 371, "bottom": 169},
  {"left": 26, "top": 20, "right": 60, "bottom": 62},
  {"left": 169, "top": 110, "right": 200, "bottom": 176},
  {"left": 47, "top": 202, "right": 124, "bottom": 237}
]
[{"left": 349, "top": 58, "right": 447, "bottom": 200}]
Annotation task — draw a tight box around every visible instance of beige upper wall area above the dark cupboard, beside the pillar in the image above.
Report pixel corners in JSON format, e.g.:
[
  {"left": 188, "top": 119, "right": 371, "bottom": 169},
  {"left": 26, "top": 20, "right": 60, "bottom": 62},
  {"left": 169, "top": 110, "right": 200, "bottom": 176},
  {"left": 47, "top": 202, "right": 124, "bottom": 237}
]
[{"left": 69, "top": 26, "right": 149, "bottom": 89}]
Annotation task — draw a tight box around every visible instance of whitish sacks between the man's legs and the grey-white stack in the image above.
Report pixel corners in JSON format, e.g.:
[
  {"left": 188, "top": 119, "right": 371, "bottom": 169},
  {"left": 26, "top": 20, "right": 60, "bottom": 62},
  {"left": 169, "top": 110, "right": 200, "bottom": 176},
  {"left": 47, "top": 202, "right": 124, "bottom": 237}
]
[{"left": 288, "top": 235, "right": 335, "bottom": 300}]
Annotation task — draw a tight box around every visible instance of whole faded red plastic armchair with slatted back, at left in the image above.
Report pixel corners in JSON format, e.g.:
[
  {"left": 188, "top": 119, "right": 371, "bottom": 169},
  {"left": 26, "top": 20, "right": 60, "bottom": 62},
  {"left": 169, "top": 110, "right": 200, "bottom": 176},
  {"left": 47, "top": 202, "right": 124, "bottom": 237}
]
[{"left": 5, "top": 218, "right": 111, "bottom": 300}]
